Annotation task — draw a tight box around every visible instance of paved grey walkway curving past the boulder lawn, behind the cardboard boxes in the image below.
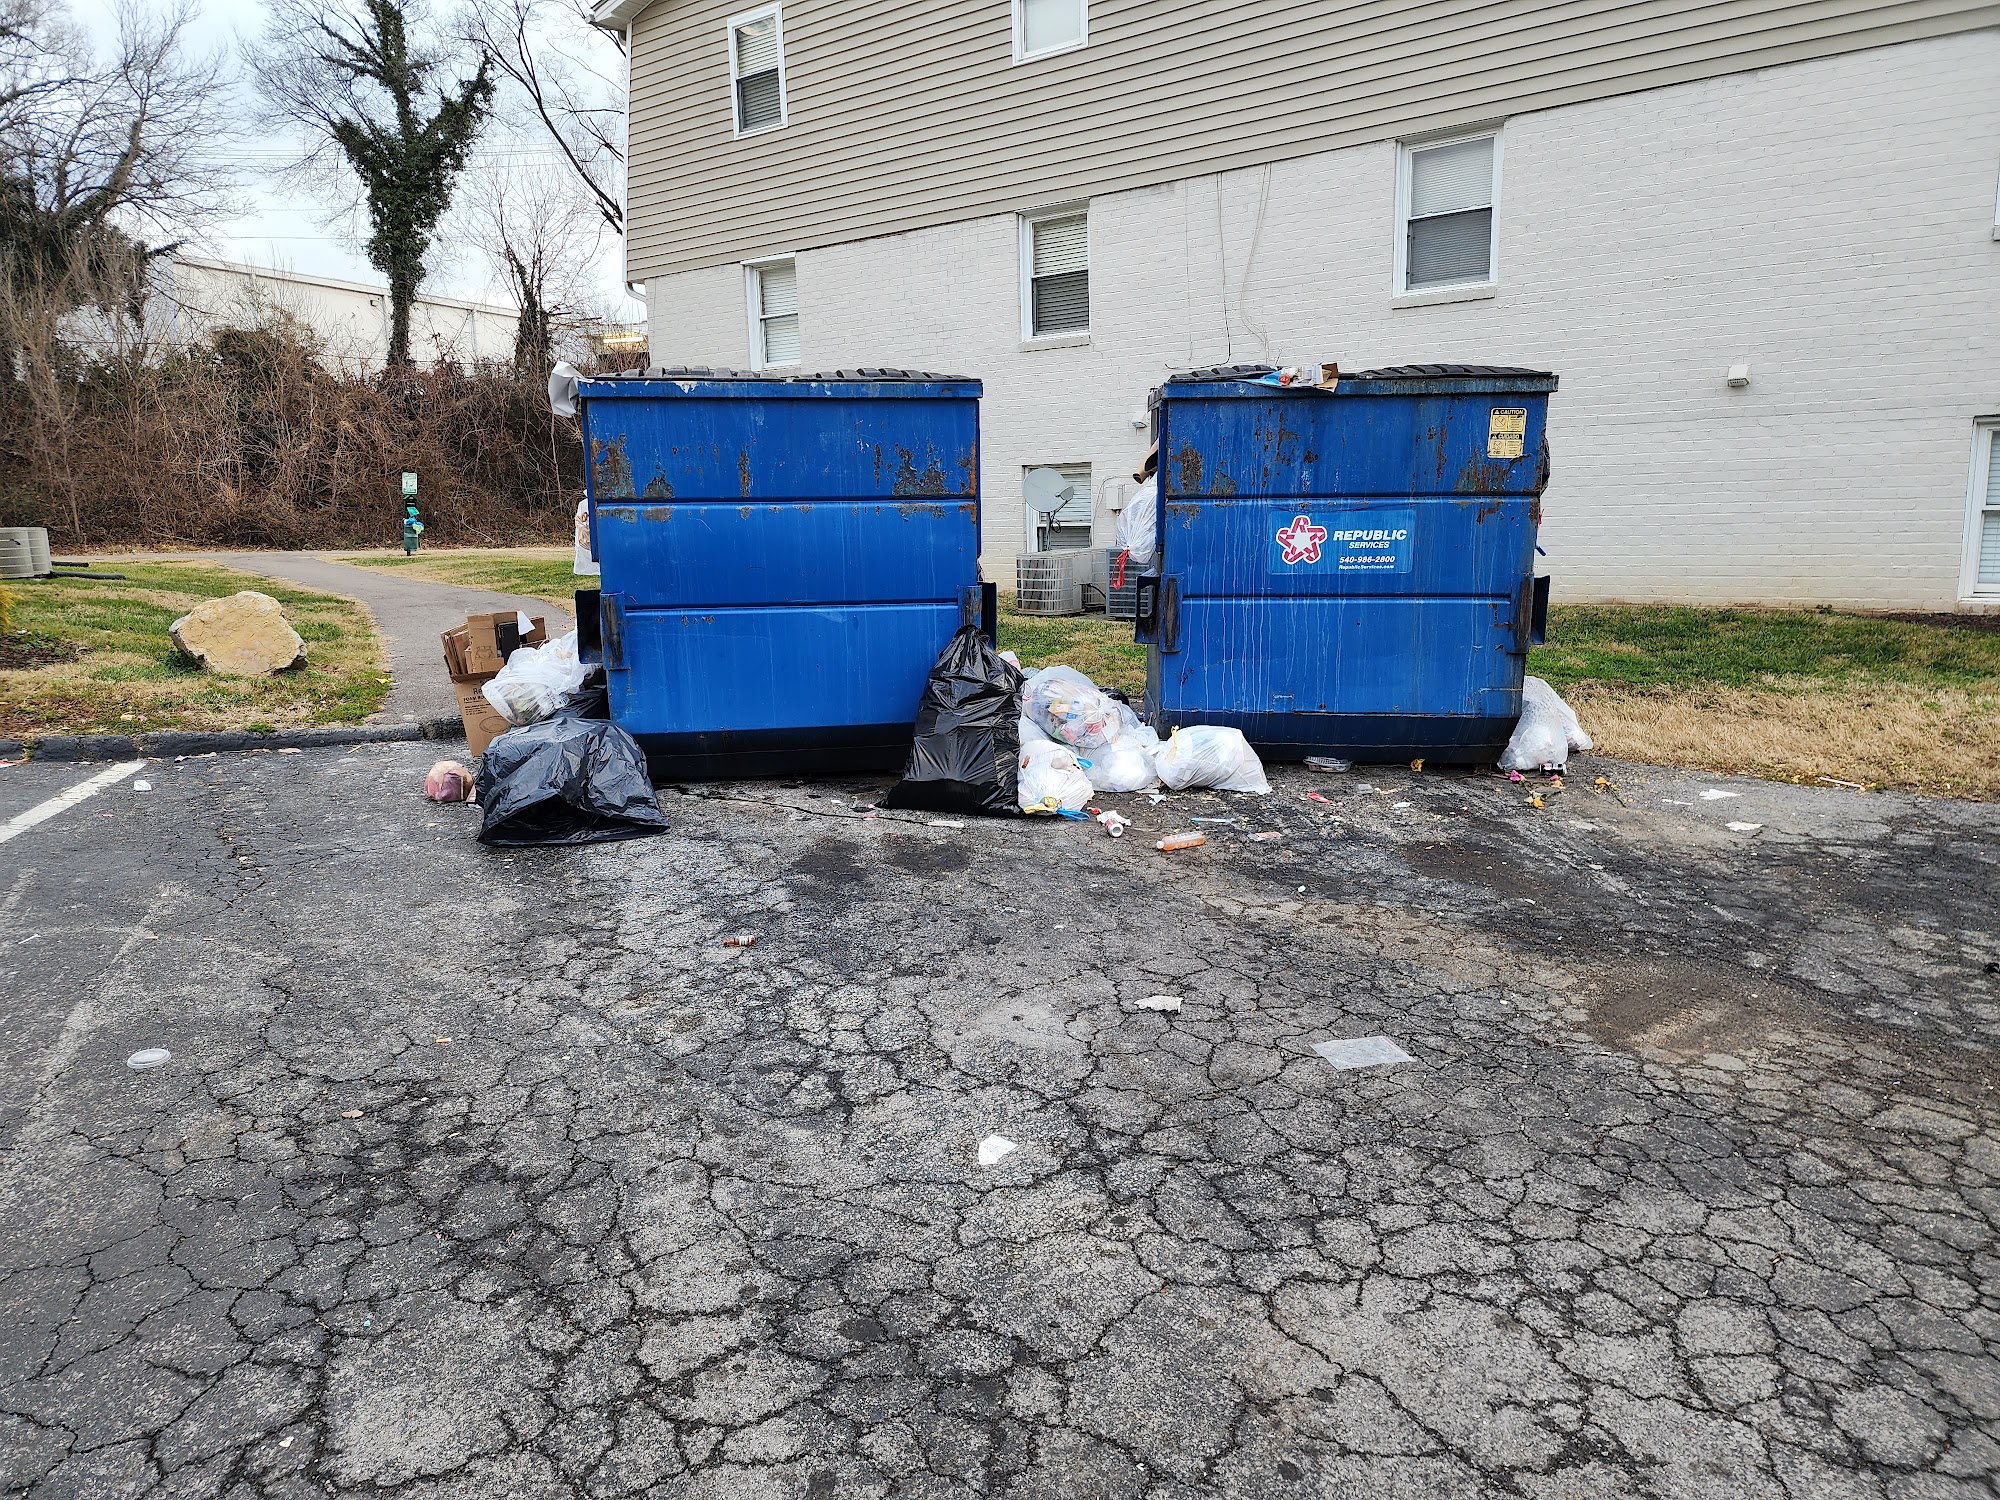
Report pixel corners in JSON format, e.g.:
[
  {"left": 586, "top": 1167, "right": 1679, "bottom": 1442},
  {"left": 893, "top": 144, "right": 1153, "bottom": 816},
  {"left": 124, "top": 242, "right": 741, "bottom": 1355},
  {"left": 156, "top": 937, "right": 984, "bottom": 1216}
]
[{"left": 207, "top": 552, "right": 572, "bottom": 724}]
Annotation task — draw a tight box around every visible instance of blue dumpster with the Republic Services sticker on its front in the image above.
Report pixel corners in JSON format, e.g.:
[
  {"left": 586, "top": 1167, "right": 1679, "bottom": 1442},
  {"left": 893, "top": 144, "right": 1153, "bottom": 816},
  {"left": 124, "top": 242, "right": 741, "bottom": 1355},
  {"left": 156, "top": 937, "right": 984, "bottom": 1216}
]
[{"left": 1138, "top": 364, "right": 1556, "bottom": 762}]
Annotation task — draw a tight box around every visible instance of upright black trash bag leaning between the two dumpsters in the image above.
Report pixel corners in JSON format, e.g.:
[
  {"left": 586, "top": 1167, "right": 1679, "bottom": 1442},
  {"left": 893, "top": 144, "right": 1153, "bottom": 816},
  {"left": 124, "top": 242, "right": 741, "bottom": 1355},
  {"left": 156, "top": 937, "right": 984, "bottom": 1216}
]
[{"left": 882, "top": 626, "right": 1022, "bottom": 818}]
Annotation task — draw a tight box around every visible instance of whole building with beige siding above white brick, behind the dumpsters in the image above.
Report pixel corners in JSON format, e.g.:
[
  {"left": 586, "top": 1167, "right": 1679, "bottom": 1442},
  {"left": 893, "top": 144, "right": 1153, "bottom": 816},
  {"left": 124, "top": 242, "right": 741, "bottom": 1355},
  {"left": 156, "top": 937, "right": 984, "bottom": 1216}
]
[{"left": 596, "top": 0, "right": 2000, "bottom": 610}]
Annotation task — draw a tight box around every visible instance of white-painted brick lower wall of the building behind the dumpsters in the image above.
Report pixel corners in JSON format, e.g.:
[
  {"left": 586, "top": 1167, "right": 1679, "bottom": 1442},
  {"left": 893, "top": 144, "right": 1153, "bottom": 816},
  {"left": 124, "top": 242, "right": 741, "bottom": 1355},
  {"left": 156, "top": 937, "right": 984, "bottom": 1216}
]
[{"left": 650, "top": 30, "right": 2000, "bottom": 608}]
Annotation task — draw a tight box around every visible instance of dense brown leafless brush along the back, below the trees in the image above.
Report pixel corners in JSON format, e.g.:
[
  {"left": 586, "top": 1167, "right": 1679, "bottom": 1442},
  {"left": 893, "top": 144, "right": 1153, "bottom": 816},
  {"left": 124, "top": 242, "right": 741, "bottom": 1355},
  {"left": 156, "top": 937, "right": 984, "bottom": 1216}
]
[{"left": 0, "top": 316, "right": 582, "bottom": 548}]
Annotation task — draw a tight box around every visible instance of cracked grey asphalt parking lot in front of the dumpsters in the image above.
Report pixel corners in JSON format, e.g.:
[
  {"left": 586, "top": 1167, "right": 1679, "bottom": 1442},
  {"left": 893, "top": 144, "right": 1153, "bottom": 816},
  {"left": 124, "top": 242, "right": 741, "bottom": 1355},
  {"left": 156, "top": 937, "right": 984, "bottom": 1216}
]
[{"left": 0, "top": 744, "right": 2000, "bottom": 1500}]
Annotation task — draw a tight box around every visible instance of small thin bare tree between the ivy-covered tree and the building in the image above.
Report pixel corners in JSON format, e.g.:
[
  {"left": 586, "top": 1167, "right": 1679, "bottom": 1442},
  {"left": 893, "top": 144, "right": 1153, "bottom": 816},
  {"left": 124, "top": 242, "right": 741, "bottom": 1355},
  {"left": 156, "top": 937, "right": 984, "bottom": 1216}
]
[{"left": 464, "top": 164, "right": 604, "bottom": 374}]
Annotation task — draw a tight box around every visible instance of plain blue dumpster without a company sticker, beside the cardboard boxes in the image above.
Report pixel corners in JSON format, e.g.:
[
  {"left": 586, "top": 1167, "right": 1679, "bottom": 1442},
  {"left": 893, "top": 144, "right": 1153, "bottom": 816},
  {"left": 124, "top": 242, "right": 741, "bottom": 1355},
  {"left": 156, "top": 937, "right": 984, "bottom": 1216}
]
[{"left": 578, "top": 370, "right": 982, "bottom": 776}]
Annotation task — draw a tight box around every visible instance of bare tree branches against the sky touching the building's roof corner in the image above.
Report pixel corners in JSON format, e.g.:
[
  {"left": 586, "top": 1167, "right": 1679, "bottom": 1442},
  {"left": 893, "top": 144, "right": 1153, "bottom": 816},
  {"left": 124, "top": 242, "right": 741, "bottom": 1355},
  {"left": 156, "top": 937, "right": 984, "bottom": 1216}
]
[{"left": 458, "top": 0, "right": 626, "bottom": 234}]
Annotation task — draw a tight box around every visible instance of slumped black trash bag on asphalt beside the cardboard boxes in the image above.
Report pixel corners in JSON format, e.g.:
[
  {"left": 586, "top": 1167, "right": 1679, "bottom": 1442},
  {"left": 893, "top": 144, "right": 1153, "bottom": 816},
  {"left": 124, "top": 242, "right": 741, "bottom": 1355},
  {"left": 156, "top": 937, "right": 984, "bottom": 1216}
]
[{"left": 476, "top": 712, "right": 666, "bottom": 848}]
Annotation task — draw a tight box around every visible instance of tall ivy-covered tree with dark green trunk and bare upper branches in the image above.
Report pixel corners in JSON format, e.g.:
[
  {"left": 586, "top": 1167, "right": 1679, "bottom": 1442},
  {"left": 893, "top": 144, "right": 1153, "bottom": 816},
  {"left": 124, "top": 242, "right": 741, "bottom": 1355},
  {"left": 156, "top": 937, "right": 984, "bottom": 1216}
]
[{"left": 254, "top": 0, "right": 494, "bottom": 366}]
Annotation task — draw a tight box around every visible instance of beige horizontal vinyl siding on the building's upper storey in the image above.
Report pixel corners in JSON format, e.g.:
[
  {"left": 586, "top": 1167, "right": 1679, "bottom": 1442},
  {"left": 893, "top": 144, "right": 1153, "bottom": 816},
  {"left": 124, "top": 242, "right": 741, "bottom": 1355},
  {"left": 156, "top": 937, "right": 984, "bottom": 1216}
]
[{"left": 630, "top": 0, "right": 2000, "bottom": 278}]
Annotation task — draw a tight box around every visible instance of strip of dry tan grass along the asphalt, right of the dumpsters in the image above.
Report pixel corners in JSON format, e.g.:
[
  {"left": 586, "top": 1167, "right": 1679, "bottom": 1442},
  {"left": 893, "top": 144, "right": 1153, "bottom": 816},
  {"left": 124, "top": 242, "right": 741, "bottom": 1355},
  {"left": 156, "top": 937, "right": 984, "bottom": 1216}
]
[{"left": 1562, "top": 682, "right": 2000, "bottom": 800}]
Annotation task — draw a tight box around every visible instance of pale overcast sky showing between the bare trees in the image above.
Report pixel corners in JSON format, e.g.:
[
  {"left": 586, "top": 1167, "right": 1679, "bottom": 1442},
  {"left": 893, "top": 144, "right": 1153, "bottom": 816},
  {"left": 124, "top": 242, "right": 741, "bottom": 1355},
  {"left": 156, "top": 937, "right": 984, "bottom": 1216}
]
[{"left": 70, "top": 0, "right": 644, "bottom": 318}]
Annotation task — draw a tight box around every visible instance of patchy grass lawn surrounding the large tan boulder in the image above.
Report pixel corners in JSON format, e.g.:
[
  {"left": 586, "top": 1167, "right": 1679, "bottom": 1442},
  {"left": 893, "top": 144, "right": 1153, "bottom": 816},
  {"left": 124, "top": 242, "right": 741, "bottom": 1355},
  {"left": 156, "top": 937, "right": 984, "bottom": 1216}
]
[{"left": 0, "top": 562, "right": 388, "bottom": 740}]
